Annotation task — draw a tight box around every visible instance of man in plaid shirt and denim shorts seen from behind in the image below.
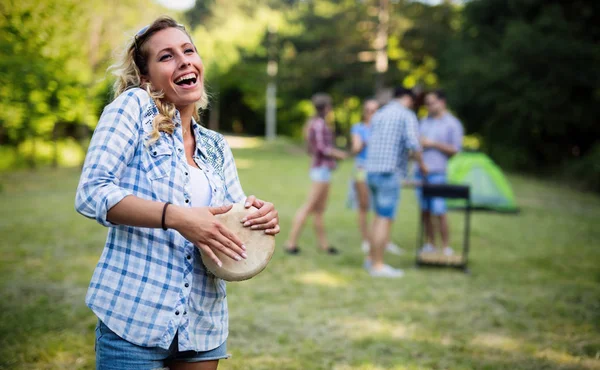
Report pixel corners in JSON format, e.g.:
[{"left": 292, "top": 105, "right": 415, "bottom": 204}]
[{"left": 365, "top": 87, "right": 427, "bottom": 278}]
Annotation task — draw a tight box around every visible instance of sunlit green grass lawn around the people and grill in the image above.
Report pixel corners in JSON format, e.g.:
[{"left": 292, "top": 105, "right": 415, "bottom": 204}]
[{"left": 0, "top": 139, "right": 600, "bottom": 370}]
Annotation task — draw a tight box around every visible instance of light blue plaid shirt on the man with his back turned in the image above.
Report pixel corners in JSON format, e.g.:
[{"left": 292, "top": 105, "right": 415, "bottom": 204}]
[{"left": 365, "top": 100, "right": 421, "bottom": 176}]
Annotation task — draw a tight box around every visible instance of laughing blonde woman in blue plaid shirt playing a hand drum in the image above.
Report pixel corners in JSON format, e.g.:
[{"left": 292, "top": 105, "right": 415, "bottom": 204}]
[{"left": 76, "top": 17, "right": 279, "bottom": 370}]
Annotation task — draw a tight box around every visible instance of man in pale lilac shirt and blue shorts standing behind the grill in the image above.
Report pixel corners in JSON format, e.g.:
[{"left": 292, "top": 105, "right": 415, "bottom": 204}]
[{"left": 415, "top": 90, "right": 464, "bottom": 255}]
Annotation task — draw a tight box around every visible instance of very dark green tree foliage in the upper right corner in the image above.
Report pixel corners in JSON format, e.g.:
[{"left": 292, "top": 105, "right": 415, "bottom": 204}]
[{"left": 440, "top": 0, "right": 600, "bottom": 169}]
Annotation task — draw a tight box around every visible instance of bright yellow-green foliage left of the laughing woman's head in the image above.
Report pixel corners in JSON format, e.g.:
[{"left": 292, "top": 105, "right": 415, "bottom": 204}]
[{"left": 0, "top": 0, "right": 173, "bottom": 166}]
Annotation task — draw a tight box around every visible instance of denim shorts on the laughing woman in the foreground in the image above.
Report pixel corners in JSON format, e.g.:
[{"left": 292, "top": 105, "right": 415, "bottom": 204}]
[{"left": 95, "top": 320, "right": 230, "bottom": 370}]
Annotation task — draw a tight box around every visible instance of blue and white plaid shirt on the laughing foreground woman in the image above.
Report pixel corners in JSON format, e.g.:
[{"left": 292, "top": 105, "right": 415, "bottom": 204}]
[{"left": 75, "top": 88, "right": 245, "bottom": 351}]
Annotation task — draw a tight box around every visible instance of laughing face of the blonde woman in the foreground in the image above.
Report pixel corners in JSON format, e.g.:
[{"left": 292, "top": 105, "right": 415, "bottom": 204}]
[{"left": 143, "top": 28, "right": 204, "bottom": 111}]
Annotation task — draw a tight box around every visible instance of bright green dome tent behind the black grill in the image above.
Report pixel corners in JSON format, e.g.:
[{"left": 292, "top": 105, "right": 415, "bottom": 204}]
[{"left": 448, "top": 152, "right": 519, "bottom": 212}]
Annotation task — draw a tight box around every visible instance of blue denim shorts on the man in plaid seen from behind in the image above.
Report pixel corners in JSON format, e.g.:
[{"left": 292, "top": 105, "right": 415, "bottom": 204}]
[{"left": 367, "top": 172, "right": 400, "bottom": 220}]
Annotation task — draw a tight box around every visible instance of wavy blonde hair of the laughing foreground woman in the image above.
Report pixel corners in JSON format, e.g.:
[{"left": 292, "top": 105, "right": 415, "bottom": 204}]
[{"left": 109, "top": 16, "right": 208, "bottom": 144}]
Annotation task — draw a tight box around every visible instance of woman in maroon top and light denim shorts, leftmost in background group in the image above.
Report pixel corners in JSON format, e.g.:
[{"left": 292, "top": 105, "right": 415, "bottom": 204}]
[{"left": 285, "top": 93, "right": 346, "bottom": 254}]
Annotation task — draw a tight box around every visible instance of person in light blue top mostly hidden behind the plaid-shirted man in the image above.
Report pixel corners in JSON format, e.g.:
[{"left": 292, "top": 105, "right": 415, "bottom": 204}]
[{"left": 350, "top": 99, "right": 402, "bottom": 261}]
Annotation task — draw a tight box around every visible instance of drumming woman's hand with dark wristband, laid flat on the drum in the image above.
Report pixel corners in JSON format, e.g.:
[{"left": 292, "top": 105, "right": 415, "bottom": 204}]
[{"left": 169, "top": 205, "right": 247, "bottom": 266}]
